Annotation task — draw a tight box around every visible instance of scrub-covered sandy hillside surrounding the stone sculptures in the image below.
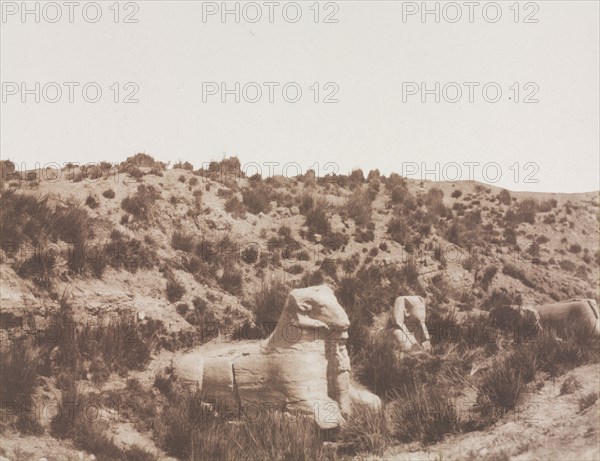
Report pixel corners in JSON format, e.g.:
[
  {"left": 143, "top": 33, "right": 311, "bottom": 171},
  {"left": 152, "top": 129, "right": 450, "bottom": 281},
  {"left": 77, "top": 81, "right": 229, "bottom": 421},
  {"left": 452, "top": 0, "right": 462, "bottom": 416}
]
[{"left": 0, "top": 154, "right": 600, "bottom": 461}]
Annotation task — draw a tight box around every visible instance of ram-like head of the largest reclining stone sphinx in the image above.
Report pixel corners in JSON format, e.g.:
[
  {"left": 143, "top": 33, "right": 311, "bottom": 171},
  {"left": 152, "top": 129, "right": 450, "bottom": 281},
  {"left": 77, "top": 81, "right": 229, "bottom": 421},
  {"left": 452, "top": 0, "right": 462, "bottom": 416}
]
[{"left": 285, "top": 285, "right": 350, "bottom": 332}]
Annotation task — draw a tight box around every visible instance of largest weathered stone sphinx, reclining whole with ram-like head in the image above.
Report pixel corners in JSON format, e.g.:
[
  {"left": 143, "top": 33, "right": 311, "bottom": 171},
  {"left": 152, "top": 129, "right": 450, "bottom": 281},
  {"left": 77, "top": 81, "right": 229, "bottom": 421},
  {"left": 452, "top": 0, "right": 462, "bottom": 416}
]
[{"left": 174, "top": 285, "right": 381, "bottom": 428}]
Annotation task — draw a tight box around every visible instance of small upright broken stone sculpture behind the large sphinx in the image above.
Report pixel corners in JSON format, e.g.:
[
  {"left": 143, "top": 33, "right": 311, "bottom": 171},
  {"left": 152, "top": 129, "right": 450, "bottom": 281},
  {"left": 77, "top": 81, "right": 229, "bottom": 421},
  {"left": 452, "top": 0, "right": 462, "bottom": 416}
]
[{"left": 385, "top": 296, "right": 431, "bottom": 352}]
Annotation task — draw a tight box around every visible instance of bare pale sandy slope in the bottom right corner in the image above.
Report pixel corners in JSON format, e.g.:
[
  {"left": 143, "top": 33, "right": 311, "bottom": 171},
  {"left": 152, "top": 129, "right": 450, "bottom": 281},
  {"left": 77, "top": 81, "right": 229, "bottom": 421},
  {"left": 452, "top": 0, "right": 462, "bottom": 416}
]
[{"left": 385, "top": 365, "right": 600, "bottom": 461}]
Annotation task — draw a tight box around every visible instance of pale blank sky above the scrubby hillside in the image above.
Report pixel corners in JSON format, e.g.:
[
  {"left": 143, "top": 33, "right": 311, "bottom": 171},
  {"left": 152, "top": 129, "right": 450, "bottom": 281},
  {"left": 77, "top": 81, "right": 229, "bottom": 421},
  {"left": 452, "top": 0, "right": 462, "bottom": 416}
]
[{"left": 0, "top": 1, "right": 600, "bottom": 192}]
